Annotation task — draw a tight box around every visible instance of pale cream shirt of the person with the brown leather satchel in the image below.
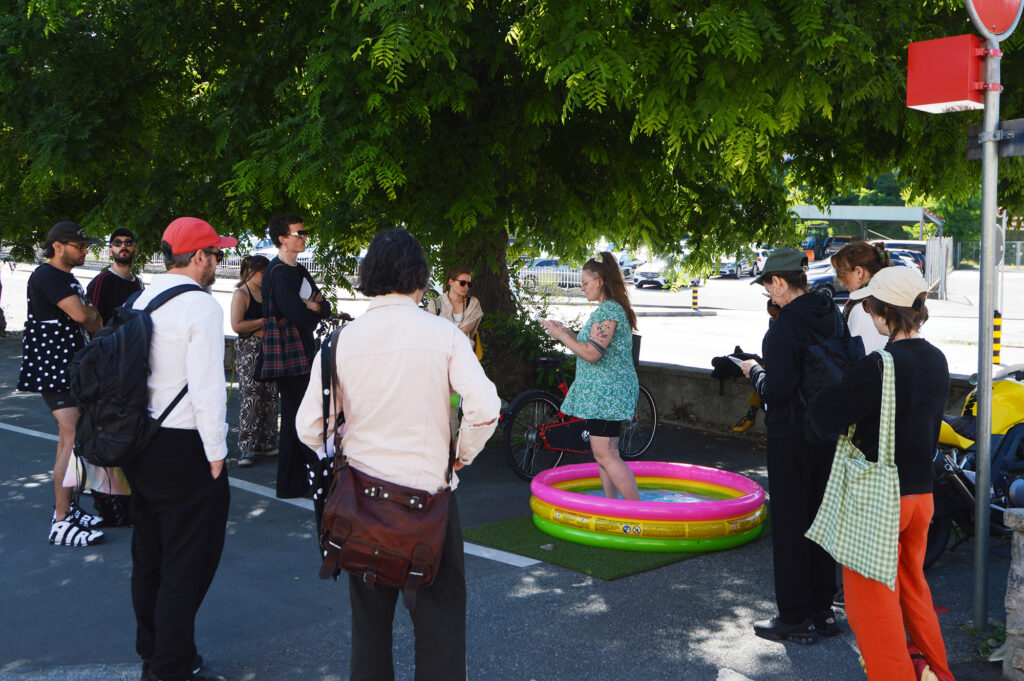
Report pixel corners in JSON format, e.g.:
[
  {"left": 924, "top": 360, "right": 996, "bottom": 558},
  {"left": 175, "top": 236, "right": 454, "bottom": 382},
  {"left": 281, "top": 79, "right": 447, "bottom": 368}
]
[{"left": 295, "top": 294, "right": 501, "bottom": 493}]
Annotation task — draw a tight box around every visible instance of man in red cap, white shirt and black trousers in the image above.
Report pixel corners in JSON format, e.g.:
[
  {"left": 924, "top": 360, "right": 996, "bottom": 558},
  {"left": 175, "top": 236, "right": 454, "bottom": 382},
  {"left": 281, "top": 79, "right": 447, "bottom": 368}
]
[{"left": 124, "top": 217, "right": 238, "bottom": 681}]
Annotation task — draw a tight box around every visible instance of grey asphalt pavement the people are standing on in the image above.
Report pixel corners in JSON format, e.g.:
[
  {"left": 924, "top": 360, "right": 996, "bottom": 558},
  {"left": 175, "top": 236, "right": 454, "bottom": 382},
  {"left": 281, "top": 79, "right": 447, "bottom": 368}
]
[{"left": 0, "top": 329, "right": 1010, "bottom": 681}]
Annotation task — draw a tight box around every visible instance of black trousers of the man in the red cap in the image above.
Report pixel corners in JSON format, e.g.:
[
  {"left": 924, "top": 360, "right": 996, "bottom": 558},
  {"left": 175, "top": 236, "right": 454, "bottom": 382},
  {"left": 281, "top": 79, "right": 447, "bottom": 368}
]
[{"left": 124, "top": 428, "right": 230, "bottom": 681}]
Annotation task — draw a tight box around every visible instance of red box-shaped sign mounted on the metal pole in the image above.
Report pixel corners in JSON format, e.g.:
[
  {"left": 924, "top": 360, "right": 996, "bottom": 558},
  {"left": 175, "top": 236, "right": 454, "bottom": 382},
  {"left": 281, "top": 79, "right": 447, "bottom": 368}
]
[{"left": 906, "top": 34, "right": 985, "bottom": 114}]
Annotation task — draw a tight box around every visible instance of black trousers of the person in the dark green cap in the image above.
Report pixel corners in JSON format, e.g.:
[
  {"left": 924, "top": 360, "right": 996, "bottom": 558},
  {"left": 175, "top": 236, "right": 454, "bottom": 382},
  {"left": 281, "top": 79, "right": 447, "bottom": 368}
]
[{"left": 768, "top": 435, "right": 836, "bottom": 624}]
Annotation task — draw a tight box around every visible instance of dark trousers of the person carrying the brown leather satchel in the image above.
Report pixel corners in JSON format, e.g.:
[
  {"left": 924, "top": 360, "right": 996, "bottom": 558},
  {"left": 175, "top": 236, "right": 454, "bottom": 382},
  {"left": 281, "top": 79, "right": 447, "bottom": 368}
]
[{"left": 348, "top": 495, "right": 466, "bottom": 681}]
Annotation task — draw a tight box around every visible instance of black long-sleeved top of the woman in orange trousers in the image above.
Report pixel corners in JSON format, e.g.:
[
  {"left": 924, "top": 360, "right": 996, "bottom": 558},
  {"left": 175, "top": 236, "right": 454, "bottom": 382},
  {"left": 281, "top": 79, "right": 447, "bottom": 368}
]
[{"left": 808, "top": 338, "right": 949, "bottom": 495}]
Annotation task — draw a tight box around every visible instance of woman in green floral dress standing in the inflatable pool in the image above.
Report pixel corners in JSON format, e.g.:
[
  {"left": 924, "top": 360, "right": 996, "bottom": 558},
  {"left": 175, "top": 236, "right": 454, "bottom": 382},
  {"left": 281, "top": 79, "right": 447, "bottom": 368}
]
[{"left": 541, "top": 251, "right": 640, "bottom": 501}]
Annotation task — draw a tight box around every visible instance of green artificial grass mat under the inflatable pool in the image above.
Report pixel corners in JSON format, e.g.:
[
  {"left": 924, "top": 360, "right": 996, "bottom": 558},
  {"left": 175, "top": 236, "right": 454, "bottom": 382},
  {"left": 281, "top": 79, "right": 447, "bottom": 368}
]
[{"left": 462, "top": 516, "right": 770, "bottom": 582}]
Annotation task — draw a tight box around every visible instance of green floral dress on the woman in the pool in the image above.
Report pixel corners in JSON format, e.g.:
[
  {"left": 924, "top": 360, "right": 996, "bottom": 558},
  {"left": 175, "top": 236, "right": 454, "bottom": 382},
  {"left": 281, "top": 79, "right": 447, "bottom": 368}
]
[{"left": 562, "top": 300, "right": 640, "bottom": 421}]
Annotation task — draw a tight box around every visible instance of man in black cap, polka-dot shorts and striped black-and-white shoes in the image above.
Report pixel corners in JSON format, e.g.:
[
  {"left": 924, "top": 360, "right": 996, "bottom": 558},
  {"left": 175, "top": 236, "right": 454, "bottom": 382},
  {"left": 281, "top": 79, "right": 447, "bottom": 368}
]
[{"left": 17, "top": 221, "right": 103, "bottom": 547}]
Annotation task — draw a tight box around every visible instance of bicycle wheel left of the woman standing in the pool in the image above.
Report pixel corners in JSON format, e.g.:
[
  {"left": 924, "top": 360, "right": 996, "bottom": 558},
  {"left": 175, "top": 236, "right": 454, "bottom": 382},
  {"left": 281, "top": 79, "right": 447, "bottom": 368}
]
[{"left": 502, "top": 390, "right": 562, "bottom": 480}]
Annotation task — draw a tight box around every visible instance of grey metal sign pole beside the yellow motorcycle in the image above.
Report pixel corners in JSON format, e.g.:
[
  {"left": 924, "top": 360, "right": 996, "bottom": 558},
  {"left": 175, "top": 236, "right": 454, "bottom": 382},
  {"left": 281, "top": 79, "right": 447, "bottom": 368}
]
[{"left": 974, "top": 38, "right": 999, "bottom": 631}]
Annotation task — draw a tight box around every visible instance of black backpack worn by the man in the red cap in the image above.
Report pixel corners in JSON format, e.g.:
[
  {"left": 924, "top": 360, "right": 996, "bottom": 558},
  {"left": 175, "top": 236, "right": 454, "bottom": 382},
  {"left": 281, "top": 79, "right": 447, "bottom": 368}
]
[{"left": 71, "top": 284, "right": 203, "bottom": 467}]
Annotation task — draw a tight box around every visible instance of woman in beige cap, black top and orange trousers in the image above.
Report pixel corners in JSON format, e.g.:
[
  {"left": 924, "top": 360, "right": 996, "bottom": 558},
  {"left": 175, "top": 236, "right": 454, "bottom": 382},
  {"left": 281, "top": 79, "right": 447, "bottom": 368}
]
[{"left": 808, "top": 267, "right": 953, "bottom": 681}]
